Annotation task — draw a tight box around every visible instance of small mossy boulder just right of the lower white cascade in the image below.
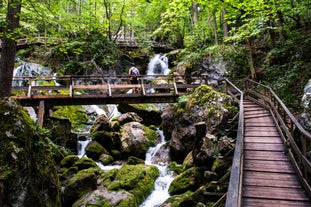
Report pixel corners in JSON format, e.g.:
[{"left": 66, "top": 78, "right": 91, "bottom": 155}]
[{"left": 169, "top": 167, "right": 204, "bottom": 195}]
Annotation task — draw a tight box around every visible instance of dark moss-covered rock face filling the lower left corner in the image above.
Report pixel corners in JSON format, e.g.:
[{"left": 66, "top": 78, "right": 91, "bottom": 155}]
[{"left": 0, "top": 99, "right": 61, "bottom": 207}]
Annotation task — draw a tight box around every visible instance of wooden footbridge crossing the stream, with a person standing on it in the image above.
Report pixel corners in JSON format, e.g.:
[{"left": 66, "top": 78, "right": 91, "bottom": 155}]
[{"left": 12, "top": 75, "right": 202, "bottom": 125}]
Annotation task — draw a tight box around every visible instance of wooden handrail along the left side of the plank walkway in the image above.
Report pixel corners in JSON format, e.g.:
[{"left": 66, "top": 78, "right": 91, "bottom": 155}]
[{"left": 225, "top": 79, "right": 244, "bottom": 207}]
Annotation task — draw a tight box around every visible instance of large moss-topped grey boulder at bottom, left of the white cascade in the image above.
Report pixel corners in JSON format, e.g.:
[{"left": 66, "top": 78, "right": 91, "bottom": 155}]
[{"left": 73, "top": 164, "right": 159, "bottom": 207}]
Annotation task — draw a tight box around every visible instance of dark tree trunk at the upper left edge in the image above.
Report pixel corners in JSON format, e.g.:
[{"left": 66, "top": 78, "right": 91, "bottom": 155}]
[{"left": 0, "top": 0, "right": 22, "bottom": 98}]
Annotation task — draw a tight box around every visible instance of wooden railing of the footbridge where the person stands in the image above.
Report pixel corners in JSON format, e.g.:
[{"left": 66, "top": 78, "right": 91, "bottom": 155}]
[{"left": 12, "top": 75, "right": 206, "bottom": 99}]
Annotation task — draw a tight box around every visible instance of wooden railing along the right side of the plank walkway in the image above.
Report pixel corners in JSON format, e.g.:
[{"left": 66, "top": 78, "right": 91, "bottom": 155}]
[{"left": 245, "top": 80, "right": 311, "bottom": 197}]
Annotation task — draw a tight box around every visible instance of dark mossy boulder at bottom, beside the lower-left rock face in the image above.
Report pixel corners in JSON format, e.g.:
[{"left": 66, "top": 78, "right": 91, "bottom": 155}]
[{"left": 63, "top": 168, "right": 98, "bottom": 206}]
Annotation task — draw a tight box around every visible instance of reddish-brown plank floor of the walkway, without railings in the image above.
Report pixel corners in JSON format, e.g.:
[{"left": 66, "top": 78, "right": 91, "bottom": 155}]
[{"left": 242, "top": 100, "right": 311, "bottom": 207}]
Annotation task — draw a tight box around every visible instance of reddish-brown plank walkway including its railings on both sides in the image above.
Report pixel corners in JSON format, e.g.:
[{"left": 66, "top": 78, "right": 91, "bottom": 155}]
[{"left": 226, "top": 80, "right": 311, "bottom": 207}]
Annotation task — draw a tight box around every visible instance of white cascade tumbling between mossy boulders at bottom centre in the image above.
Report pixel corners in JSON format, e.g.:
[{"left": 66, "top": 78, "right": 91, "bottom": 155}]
[{"left": 140, "top": 130, "right": 174, "bottom": 207}]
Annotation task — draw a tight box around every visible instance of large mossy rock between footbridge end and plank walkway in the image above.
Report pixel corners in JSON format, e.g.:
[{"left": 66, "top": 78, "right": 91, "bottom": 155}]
[{"left": 161, "top": 85, "right": 237, "bottom": 162}]
